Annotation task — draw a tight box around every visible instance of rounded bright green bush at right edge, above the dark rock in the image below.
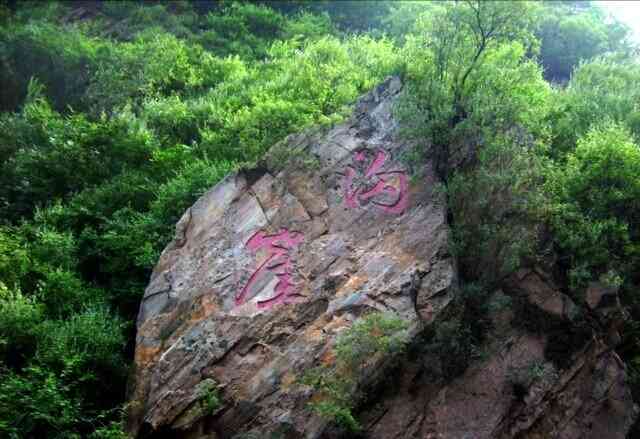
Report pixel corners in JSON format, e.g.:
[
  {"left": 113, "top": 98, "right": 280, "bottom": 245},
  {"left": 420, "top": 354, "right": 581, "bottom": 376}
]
[{"left": 548, "top": 123, "right": 640, "bottom": 287}]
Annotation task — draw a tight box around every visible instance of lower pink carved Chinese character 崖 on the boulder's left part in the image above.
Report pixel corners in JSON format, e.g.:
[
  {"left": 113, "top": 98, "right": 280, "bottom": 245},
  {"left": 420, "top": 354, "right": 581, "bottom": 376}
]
[{"left": 236, "top": 229, "right": 304, "bottom": 309}]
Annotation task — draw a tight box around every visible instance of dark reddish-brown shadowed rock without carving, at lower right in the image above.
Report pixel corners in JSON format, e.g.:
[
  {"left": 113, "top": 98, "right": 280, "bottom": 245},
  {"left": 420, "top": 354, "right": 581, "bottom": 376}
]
[{"left": 362, "top": 282, "right": 638, "bottom": 439}]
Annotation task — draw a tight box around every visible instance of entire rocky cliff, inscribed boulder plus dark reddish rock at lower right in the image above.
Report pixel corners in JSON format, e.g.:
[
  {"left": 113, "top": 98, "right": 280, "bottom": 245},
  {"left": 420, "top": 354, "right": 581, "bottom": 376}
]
[{"left": 129, "top": 78, "right": 637, "bottom": 439}]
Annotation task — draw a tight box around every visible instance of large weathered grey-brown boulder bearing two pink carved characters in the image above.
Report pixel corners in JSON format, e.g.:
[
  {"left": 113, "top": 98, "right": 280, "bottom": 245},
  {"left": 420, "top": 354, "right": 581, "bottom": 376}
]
[{"left": 130, "top": 79, "right": 456, "bottom": 438}]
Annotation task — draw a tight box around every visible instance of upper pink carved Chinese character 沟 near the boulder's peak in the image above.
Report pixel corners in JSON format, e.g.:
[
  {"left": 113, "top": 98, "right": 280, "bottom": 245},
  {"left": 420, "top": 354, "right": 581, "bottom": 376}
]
[{"left": 344, "top": 150, "right": 409, "bottom": 215}]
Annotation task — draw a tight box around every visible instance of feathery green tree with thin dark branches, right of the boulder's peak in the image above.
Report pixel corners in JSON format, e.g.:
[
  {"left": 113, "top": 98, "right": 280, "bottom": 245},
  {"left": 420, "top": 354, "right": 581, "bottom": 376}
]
[{"left": 398, "top": 2, "right": 552, "bottom": 284}]
